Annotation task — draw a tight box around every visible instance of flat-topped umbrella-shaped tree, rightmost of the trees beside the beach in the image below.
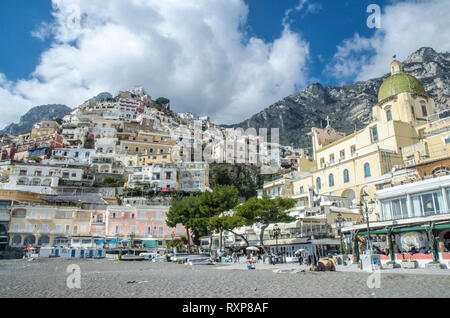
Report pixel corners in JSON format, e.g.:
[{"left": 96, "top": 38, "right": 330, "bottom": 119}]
[{"left": 235, "top": 195, "right": 295, "bottom": 253}]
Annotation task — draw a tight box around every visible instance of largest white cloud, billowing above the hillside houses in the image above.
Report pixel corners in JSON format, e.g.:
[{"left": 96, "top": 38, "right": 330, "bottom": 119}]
[{"left": 0, "top": 0, "right": 309, "bottom": 125}]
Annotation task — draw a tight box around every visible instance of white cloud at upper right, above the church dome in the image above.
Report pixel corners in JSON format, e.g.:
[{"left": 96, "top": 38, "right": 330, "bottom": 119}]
[{"left": 326, "top": 0, "right": 450, "bottom": 82}]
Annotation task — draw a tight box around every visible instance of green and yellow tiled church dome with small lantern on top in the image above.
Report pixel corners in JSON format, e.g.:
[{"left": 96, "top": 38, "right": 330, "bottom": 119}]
[{"left": 378, "top": 61, "right": 427, "bottom": 102}]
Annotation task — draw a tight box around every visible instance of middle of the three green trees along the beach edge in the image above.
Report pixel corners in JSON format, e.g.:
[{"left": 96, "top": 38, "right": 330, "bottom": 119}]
[{"left": 199, "top": 185, "right": 238, "bottom": 250}]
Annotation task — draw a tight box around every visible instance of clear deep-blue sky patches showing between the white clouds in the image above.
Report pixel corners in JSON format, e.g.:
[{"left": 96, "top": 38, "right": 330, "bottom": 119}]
[{"left": 0, "top": 0, "right": 385, "bottom": 85}]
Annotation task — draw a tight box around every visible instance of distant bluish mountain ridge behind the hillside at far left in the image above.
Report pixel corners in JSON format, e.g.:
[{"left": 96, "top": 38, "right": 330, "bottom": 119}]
[{"left": 0, "top": 104, "right": 72, "bottom": 135}]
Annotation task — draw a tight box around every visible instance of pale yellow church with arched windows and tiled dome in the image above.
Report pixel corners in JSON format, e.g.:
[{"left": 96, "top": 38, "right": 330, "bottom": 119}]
[{"left": 293, "top": 61, "right": 442, "bottom": 219}]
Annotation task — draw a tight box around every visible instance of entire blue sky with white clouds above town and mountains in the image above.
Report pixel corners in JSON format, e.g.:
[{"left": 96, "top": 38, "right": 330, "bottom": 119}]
[{"left": 0, "top": 0, "right": 450, "bottom": 128}]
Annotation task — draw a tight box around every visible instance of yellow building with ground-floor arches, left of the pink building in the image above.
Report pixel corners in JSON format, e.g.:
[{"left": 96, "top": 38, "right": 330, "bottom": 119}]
[{"left": 9, "top": 204, "right": 92, "bottom": 247}]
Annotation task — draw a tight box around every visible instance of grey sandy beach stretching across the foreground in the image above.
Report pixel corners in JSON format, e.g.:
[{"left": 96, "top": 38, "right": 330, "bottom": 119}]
[{"left": 0, "top": 259, "right": 450, "bottom": 298}]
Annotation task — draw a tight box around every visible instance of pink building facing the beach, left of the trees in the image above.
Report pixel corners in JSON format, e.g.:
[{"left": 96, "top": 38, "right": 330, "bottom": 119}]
[{"left": 105, "top": 206, "right": 186, "bottom": 247}]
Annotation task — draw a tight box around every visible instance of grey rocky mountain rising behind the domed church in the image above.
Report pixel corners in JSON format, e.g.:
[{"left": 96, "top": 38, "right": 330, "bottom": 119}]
[{"left": 233, "top": 48, "right": 450, "bottom": 148}]
